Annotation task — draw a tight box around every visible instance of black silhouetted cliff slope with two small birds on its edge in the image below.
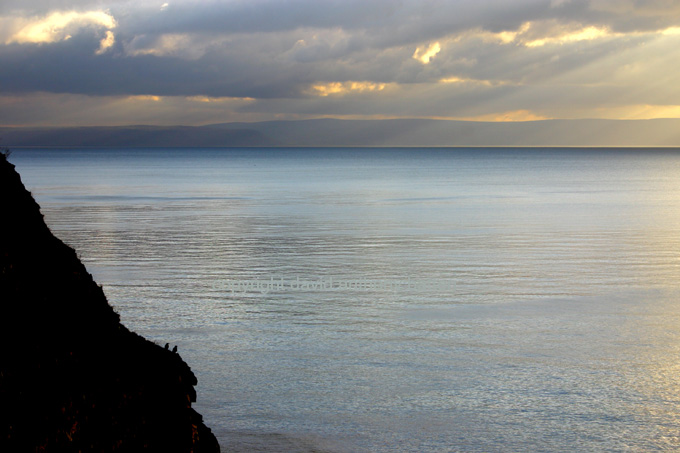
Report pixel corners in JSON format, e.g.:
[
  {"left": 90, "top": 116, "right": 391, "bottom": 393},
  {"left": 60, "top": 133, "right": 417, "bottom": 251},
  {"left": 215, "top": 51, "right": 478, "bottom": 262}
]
[{"left": 0, "top": 155, "right": 219, "bottom": 452}]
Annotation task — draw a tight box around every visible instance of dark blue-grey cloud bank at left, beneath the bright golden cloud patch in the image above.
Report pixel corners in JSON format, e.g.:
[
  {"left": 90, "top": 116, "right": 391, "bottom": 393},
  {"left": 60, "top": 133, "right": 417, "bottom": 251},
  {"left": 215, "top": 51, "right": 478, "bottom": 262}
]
[{"left": 0, "top": 37, "right": 304, "bottom": 97}]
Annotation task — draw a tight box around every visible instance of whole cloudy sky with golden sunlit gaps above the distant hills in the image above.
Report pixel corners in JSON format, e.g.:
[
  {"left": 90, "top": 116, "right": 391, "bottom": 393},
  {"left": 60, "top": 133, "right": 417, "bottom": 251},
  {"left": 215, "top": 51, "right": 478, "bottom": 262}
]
[{"left": 0, "top": 0, "right": 680, "bottom": 126}]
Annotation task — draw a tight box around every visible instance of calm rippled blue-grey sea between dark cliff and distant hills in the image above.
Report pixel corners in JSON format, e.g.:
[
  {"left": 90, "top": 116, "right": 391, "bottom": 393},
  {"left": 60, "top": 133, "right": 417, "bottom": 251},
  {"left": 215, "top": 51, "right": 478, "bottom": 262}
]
[{"left": 10, "top": 149, "right": 680, "bottom": 452}]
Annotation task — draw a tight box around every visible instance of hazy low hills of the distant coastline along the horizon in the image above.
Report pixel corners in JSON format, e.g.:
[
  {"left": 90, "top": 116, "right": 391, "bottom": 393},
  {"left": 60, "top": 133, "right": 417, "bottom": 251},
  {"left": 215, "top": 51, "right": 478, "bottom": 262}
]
[{"left": 0, "top": 119, "right": 680, "bottom": 147}]
